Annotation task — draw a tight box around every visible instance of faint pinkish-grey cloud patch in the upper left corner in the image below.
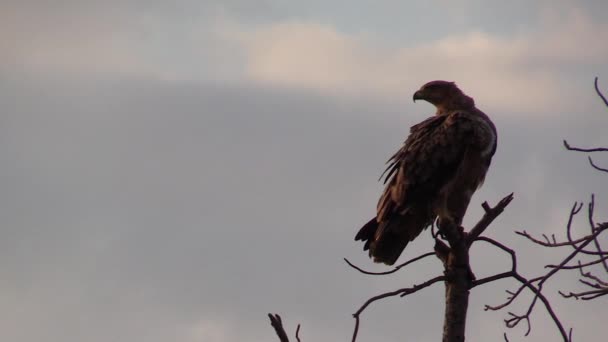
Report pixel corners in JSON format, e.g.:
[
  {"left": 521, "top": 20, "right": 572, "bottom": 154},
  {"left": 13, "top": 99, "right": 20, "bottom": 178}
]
[{"left": 0, "top": 4, "right": 139, "bottom": 73}]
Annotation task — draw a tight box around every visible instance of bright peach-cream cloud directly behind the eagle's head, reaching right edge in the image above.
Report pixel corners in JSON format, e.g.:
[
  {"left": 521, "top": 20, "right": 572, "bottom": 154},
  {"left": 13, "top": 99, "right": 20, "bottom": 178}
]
[{"left": 238, "top": 10, "right": 608, "bottom": 112}]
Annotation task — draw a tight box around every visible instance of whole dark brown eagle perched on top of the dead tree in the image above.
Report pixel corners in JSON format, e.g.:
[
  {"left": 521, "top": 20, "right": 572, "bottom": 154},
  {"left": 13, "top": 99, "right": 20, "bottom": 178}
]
[{"left": 355, "top": 81, "right": 497, "bottom": 265}]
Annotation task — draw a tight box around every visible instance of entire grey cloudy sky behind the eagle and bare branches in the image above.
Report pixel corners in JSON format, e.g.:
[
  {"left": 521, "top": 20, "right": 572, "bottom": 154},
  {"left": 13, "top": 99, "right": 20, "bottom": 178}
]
[{"left": 0, "top": 0, "right": 608, "bottom": 342}]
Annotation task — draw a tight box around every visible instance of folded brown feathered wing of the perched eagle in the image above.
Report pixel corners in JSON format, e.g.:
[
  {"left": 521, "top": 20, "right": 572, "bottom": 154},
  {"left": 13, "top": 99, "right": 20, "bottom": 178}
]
[{"left": 377, "top": 111, "right": 494, "bottom": 224}]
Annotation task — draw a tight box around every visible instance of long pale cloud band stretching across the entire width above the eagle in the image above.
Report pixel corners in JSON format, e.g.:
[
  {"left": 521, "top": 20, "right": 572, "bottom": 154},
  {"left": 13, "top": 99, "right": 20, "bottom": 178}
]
[{"left": 0, "top": 1, "right": 608, "bottom": 115}]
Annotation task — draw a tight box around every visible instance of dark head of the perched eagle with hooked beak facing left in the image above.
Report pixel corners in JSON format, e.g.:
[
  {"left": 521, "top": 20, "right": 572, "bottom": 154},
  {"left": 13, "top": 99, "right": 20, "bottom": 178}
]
[{"left": 414, "top": 81, "right": 475, "bottom": 115}]
